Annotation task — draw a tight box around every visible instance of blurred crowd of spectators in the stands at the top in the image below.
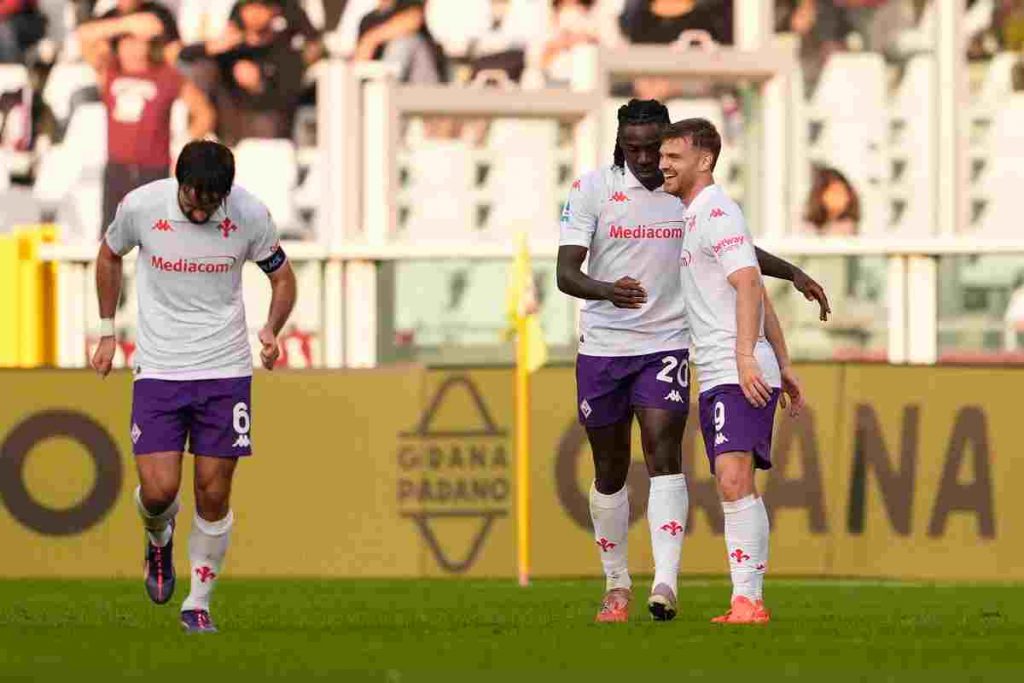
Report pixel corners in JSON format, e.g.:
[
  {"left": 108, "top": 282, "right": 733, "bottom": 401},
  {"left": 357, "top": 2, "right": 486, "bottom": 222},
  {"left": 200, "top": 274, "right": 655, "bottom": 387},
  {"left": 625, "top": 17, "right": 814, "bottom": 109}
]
[{"left": 0, "top": 0, "right": 1024, "bottom": 234}]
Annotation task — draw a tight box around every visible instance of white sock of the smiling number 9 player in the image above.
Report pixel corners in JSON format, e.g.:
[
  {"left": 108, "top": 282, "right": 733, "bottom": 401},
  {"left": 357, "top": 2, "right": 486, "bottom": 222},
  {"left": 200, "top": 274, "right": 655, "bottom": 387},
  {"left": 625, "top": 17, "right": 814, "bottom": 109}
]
[{"left": 722, "top": 496, "right": 768, "bottom": 600}]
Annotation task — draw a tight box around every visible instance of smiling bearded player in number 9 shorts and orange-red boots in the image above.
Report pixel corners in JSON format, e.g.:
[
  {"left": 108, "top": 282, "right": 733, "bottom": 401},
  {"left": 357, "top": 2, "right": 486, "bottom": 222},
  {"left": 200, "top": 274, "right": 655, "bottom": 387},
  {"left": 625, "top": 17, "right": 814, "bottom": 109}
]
[{"left": 660, "top": 119, "right": 804, "bottom": 624}]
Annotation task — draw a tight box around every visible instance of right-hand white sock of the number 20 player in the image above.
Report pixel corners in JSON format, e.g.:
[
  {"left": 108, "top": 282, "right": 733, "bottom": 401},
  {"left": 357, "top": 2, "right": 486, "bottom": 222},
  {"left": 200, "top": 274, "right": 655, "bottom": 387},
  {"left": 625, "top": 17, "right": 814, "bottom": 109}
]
[{"left": 647, "top": 474, "right": 690, "bottom": 593}]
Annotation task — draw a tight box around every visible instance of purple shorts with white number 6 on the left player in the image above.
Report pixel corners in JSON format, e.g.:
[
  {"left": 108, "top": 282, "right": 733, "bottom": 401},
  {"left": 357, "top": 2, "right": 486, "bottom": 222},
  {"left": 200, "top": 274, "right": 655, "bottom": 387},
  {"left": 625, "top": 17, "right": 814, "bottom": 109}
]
[{"left": 131, "top": 377, "right": 252, "bottom": 458}]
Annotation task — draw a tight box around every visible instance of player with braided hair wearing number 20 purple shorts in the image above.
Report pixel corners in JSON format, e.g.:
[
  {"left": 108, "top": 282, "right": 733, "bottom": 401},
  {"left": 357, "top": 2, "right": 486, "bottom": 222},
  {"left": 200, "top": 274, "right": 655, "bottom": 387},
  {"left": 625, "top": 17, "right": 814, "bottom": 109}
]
[{"left": 557, "top": 99, "right": 827, "bottom": 622}]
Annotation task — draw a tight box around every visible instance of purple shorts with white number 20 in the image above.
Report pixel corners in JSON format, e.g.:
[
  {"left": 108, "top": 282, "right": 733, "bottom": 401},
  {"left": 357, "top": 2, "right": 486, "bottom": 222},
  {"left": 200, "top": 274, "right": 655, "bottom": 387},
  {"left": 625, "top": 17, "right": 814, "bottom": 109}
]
[{"left": 577, "top": 349, "right": 690, "bottom": 427}]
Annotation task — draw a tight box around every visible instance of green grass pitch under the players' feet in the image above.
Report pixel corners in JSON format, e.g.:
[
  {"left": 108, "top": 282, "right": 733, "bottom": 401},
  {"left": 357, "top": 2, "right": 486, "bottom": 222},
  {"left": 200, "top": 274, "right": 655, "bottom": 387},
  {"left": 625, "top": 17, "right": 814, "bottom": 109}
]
[{"left": 0, "top": 578, "right": 1024, "bottom": 683}]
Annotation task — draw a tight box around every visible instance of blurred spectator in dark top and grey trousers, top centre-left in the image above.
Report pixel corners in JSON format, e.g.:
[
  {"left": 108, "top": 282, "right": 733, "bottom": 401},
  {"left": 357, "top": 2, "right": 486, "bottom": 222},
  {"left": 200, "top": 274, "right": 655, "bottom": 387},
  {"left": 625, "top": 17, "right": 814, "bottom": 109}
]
[{"left": 353, "top": 0, "right": 447, "bottom": 83}]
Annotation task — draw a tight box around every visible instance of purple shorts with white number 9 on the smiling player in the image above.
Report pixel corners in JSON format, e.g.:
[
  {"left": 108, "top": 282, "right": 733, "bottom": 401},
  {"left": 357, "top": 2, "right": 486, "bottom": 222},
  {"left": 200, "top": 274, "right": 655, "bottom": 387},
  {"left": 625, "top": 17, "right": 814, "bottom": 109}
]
[{"left": 699, "top": 384, "right": 779, "bottom": 474}]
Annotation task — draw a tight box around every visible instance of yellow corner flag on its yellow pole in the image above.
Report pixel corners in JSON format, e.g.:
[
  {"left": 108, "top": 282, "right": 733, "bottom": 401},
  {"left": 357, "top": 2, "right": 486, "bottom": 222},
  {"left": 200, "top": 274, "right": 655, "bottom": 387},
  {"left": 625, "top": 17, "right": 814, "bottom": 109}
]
[{"left": 508, "top": 232, "right": 548, "bottom": 586}]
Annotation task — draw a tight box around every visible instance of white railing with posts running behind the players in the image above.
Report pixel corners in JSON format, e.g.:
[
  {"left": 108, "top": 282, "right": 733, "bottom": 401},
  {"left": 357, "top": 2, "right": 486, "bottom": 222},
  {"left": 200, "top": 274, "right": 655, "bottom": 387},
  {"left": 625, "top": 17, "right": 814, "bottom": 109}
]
[{"left": 41, "top": 237, "right": 1024, "bottom": 368}]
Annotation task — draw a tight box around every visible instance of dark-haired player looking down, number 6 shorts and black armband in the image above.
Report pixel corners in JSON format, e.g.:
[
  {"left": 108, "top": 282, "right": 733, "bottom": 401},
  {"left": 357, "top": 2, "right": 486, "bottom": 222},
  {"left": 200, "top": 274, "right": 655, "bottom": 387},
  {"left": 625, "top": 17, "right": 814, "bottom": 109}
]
[{"left": 92, "top": 140, "right": 296, "bottom": 633}]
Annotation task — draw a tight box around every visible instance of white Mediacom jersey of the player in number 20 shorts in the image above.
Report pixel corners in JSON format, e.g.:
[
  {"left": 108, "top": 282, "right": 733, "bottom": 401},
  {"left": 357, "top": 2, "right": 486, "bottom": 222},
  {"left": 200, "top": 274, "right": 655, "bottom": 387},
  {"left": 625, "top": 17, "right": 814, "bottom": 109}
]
[{"left": 558, "top": 166, "right": 689, "bottom": 356}]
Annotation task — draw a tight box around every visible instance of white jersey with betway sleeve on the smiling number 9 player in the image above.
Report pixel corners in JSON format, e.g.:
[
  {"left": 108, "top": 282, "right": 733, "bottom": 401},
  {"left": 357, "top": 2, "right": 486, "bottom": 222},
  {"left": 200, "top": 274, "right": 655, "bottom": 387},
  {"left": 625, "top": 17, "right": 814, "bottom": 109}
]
[{"left": 681, "top": 185, "right": 782, "bottom": 392}]
